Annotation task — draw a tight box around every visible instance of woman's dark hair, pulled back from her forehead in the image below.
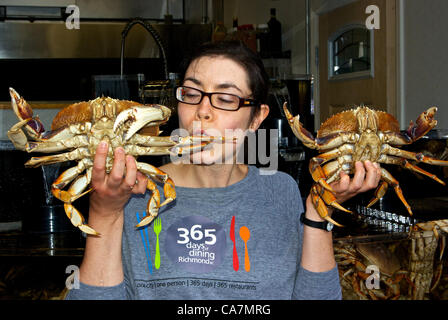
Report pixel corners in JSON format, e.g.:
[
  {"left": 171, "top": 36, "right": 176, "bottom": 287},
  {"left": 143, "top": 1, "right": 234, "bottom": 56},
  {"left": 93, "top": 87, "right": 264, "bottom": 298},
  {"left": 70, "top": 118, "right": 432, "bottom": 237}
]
[{"left": 180, "top": 40, "right": 270, "bottom": 117}]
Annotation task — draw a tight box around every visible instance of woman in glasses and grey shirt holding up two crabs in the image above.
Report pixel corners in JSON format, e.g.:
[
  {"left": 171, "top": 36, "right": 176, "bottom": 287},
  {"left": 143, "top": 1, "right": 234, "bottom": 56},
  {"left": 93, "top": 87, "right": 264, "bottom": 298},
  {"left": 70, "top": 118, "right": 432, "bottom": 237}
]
[{"left": 68, "top": 42, "right": 380, "bottom": 299}]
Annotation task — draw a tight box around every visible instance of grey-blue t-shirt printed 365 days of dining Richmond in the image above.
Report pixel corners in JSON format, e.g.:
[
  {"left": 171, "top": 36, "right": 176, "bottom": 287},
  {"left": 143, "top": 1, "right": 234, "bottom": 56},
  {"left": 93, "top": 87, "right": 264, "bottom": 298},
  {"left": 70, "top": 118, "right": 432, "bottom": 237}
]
[{"left": 67, "top": 166, "right": 341, "bottom": 300}]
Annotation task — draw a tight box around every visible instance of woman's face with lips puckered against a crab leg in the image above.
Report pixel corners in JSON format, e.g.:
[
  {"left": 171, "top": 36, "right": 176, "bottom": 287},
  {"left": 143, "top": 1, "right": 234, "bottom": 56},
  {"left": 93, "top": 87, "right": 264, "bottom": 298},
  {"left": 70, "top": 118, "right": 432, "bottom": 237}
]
[{"left": 178, "top": 56, "right": 267, "bottom": 164}]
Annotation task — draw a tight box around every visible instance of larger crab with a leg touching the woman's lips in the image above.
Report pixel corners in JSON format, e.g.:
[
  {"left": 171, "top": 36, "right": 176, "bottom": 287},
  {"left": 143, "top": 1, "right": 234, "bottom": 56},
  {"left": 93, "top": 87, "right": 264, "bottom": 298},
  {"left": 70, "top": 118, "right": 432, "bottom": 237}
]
[{"left": 8, "top": 88, "right": 224, "bottom": 235}]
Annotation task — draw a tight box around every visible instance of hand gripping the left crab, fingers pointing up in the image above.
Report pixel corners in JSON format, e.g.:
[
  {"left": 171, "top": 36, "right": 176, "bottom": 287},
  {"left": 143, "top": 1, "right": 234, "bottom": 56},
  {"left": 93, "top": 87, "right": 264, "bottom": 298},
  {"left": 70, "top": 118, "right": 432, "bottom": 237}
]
[{"left": 89, "top": 141, "right": 147, "bottom": 219}]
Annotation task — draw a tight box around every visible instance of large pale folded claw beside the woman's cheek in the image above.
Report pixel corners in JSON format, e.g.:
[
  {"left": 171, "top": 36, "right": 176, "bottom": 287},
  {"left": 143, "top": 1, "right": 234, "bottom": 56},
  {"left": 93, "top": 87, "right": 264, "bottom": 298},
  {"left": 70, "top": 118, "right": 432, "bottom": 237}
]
[{"left": 113, "top": 104, "right": 171, "bottom": 141}]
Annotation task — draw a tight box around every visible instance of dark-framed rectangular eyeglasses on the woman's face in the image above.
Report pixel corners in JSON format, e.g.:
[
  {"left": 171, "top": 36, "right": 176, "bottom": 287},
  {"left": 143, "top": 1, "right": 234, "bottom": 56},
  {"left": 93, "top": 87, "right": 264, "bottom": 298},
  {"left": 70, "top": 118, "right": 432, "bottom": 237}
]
[{"left": 176, "top": 87, "right": 259, "bottom": 111}]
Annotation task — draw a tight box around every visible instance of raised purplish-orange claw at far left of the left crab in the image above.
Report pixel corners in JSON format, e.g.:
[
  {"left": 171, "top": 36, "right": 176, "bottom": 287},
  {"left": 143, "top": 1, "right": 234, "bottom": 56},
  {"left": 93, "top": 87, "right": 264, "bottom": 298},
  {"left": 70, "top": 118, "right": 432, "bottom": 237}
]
[{"left": 9, "top": 88, "right": 45, "bottom": 139}]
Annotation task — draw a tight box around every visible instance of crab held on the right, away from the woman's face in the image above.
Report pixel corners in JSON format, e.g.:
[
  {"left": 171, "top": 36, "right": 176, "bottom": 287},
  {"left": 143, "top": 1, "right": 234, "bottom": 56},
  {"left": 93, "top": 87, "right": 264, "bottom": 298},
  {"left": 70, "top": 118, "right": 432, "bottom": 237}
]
[{"left": 283, "top": 103, "right": 448, "bottom": 227}]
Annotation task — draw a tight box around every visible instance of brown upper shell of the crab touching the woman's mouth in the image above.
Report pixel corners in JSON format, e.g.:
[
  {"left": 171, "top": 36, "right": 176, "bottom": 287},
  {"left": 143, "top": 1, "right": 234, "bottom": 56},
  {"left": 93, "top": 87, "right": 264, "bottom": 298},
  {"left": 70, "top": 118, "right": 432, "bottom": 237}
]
[{"left": 51, "top": 100, "right": 159, "bottom": 136}]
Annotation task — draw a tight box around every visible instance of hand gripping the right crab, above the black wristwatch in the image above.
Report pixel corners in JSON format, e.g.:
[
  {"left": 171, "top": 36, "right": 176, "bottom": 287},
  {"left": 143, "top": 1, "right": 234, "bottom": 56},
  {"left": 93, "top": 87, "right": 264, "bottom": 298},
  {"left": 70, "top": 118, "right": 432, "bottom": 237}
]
[{"left": 330, "top": 161, "right": 381, "bottom": 203}]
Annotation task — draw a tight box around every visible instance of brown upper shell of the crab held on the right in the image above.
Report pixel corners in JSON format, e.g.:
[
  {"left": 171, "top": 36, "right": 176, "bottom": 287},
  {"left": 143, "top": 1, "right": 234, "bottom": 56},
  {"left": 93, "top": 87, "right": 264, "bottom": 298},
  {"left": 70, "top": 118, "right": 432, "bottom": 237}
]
[{"left": 317, "top": 107, "right": 400, "bottom": 138}]
